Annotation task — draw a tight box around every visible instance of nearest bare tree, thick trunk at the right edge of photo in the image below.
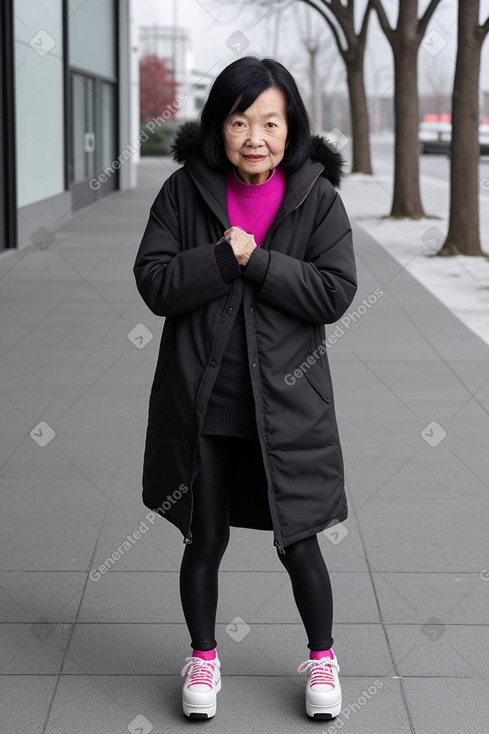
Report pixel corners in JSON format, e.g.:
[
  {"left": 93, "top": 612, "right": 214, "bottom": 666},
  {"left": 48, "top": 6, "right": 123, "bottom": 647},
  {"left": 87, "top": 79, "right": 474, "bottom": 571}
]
[{"left": 437, "top": 0, "right": 489, "bottom": 256}]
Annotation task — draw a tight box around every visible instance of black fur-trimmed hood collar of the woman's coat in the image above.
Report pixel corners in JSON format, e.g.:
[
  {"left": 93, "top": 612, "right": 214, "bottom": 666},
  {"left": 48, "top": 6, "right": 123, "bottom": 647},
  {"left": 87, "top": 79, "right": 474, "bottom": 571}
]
[{"left": 171, "top": 120, "right": 344, "bottom": 231}]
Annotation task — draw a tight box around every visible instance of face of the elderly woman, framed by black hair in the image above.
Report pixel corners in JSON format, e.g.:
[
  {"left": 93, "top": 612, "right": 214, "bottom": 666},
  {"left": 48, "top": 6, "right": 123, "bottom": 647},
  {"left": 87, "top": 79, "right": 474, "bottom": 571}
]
[{"left": 222, "top": 87, "right": 287, "bottom": 184}]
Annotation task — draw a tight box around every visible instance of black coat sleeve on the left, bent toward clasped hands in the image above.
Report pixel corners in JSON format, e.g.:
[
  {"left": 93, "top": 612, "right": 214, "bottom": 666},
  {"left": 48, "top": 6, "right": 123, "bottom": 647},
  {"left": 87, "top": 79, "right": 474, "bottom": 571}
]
[{"left": 133, "top": 176, "right": 240, "bottom": 316}]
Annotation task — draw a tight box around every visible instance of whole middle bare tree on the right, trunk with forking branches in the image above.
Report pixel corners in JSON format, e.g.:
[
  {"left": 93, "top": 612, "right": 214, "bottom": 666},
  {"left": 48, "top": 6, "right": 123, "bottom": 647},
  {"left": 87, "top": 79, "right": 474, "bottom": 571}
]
[{"left": 371, "top": 0, "right": 442, "bottom": 217}]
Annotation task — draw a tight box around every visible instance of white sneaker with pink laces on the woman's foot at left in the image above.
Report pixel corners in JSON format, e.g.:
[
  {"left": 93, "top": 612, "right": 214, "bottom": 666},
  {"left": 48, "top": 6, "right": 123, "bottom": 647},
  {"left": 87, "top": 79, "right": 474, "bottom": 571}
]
[{"left": 182, "top": 652, "right": 221, "bottom": 719}]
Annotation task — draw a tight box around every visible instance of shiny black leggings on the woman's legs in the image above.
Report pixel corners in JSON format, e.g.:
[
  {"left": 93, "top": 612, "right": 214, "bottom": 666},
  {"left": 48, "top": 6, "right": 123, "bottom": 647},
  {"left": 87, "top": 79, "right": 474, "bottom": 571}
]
[{"left": 180, "top": 436, "right": 333, "bottom": 650}]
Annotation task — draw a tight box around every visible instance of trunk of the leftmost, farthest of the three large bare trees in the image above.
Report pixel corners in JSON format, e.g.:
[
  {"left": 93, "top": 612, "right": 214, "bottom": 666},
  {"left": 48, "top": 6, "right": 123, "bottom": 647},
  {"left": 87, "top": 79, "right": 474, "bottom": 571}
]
[{"left": 346, "top": 53, "right": 372, "bottom": 175}]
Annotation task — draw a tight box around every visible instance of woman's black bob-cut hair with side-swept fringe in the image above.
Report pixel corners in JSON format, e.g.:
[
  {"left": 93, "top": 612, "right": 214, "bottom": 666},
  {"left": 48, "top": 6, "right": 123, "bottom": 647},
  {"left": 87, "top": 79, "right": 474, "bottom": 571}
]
[{"left": 200, "top": 56, "right": 312, "bottom": 172}]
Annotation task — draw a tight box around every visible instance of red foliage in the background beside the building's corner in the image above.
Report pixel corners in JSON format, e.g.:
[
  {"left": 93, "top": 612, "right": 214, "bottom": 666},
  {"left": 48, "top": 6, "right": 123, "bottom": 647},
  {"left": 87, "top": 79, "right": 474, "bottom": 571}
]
[{"left": 139, "top": 54, "right": 178, "bottom": 123}]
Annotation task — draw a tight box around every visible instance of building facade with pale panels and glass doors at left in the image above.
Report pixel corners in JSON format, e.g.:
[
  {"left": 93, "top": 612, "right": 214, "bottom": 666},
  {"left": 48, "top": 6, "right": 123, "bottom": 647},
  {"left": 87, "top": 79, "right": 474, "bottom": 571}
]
[{"left": 0, "top": 0, "right": 140, "bottom": 249}]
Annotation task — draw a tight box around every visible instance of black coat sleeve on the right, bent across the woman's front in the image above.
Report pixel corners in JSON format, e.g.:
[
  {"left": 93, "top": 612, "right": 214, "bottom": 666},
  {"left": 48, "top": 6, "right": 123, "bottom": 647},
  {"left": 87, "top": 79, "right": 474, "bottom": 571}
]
[{"left": 243, "top": 187, "right": 357, "bottom": 324}]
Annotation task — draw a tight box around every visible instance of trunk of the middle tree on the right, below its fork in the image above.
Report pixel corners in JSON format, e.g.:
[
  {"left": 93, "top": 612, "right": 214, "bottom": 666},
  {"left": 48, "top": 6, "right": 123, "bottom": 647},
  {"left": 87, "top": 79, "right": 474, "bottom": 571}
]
[{"left": 390, "top": 35, "right": 425, "bottom": 218}]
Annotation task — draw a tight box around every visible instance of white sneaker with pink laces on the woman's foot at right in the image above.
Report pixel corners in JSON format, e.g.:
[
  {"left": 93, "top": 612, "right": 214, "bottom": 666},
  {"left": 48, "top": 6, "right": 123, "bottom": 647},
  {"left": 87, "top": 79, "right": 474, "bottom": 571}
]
[{"left": 297, "top": 653, "right": 341, "bottom": 719}]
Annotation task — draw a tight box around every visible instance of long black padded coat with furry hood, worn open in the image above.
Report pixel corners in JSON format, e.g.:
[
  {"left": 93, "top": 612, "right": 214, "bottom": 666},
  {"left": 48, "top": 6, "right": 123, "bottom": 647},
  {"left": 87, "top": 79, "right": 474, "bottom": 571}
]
[{"left": 134, "top": 122, "right": 357, "bottom": 552}]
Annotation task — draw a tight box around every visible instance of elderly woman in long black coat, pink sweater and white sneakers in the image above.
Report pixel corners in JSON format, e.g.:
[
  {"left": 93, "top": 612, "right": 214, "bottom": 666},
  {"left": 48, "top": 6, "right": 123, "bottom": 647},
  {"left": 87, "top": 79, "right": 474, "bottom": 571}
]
[{"left": 134, "top": 57, "right": 357, "bottom": 719}]
